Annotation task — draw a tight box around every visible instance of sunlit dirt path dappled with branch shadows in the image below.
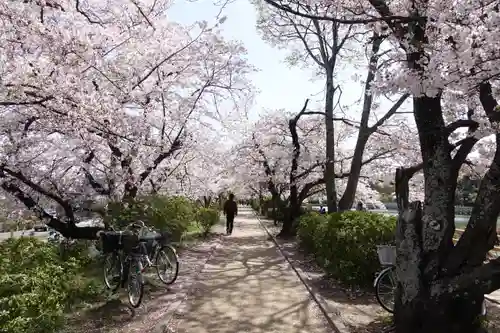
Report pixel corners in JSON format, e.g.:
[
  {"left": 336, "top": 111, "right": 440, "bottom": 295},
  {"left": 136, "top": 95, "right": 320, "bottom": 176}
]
[{"left": 166, "top": 209, "right": 333, "bottom": 333}]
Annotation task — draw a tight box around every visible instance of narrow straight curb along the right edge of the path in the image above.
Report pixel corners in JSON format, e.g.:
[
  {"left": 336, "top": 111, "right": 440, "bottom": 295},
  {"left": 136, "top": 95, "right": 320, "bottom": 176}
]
[{"left": 253, "top": 211, "right": 350, "bottom": 333}]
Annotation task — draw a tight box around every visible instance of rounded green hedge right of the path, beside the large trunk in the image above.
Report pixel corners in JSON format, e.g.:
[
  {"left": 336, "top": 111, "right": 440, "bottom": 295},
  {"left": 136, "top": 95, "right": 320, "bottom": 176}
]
[{"left": 297, "top": 211, "right": 396, "bottom": 286}]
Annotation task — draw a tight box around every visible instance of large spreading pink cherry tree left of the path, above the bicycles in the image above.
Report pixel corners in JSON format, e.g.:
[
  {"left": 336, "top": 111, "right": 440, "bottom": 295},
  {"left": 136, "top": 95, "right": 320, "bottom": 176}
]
[{"left": 0, "top": 0, "right": 252, "bottom": 238}]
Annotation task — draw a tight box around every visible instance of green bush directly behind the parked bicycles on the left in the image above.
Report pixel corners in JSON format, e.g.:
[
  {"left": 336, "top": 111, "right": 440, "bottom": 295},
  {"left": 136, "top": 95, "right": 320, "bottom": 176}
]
[{"left": 105, "top": 196, "right": 197, "bottom": 241}]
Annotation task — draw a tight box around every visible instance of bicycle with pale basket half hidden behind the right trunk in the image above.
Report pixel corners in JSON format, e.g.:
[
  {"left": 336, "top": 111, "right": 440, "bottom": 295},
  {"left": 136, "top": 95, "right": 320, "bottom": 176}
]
[{"left": 373, "top": 245, "right": 486, "bottom": 316}]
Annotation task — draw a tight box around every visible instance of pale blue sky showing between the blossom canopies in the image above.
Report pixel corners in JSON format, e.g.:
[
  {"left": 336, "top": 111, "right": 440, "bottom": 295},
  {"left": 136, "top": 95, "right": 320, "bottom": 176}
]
[{"left": 168, "top": 0, "right": 412, "bottom": 146}]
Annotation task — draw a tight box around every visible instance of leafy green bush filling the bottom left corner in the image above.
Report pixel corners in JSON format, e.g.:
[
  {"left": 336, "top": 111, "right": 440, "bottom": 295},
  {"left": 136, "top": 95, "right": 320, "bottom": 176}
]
[{"left": 0, "top": 237, "right": 103, "bottom": 333}]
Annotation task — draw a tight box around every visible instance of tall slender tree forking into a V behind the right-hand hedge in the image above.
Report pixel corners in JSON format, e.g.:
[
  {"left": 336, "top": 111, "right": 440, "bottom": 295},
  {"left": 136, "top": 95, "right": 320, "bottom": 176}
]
[{"left": 256, "top": 0, "right": 409, "bottom": 211}]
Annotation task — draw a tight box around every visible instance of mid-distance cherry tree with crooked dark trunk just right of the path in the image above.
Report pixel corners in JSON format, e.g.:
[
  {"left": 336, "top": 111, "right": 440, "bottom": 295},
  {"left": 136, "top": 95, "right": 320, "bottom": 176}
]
[{"left": 233, "top": 101, "right": 395, "bottom": 237}]
